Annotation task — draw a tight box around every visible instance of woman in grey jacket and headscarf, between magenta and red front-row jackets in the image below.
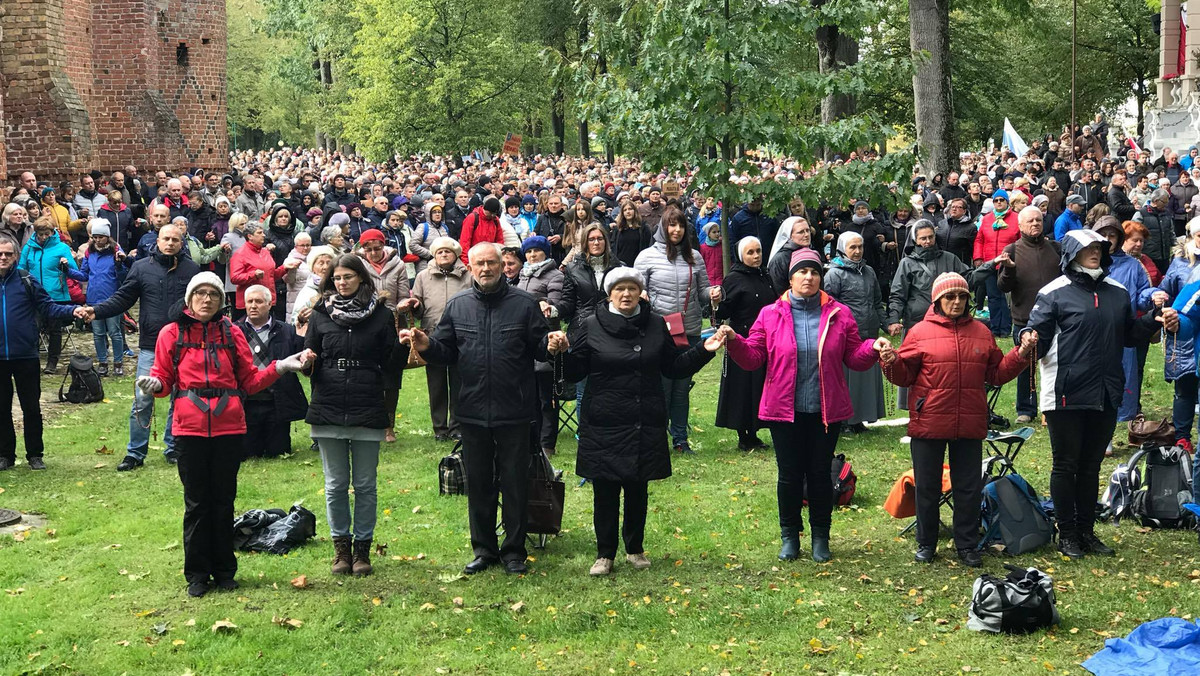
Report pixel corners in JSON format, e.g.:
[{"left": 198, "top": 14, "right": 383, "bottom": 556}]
[{"left": 823, "top": 232, "right": 886, "bottom": 433}]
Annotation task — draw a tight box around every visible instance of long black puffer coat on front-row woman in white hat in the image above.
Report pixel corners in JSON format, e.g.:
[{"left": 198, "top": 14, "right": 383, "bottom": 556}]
[{"left": 563, "top": 300, "right": 713, "bottom": 481}]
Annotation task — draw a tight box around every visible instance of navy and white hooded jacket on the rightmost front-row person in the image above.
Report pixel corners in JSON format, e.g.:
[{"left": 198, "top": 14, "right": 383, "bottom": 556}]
[{"left": 1026, "top": 231, "right": 1162, "bottom": 411}]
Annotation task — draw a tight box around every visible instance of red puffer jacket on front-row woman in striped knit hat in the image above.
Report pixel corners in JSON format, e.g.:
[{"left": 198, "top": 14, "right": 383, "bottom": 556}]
[{"left": 883, "top": 306, "right": 1028, "bottom": 439}]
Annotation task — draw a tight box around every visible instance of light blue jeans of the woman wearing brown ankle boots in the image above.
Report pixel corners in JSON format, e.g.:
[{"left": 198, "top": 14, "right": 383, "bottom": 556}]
[{"left": 317, "top": 437, "right": 379, "bottom": 540}]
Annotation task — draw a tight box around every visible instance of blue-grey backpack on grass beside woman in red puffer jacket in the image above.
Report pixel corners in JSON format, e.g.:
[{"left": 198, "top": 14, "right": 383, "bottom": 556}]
[{"left": 979, "top": 472, "right": 1055, "bottom": 556}]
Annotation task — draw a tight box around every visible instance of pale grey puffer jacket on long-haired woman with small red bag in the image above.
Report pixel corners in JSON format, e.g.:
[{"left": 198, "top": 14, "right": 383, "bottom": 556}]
[{"left": 634, "top": 226, "right": 709, "bottom": 336}]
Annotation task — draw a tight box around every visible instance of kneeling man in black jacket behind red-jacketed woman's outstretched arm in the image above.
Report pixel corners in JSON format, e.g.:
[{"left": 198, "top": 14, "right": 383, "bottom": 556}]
[{"left": 234, "top": 285, "right": 308, "bottom": 459}]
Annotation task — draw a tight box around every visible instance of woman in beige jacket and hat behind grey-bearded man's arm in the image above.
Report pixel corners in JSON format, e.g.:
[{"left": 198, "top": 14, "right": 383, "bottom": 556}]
[{"left": 409, "top": 237, "right": 470, "bottom": 441}]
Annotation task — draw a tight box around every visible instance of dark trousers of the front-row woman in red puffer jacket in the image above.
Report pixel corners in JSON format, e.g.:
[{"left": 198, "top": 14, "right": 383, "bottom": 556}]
[{"left": 910, "top": 438, "right": 983, "bottom": 549}]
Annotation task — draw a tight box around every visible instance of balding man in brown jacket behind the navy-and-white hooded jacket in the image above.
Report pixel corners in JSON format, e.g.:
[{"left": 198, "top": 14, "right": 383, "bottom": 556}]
[{"left": 996, "top": 207, "right": 1062, "bottom": 424}]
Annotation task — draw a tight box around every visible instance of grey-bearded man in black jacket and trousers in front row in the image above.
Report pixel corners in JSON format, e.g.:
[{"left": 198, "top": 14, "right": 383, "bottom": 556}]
[{"left": 400, "top": 243, "right": 566, "bottom": 575}]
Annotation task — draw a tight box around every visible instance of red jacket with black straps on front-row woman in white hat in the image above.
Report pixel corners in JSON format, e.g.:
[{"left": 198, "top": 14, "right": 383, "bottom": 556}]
[{"left": 150, "top": 314, "right": 280, "bottom": 437}]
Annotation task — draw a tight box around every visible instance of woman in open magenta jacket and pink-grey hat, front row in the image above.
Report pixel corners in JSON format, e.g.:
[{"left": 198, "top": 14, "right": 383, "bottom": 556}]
[{"left": 721, "top": 249, "right": 889, "bottom": 562}]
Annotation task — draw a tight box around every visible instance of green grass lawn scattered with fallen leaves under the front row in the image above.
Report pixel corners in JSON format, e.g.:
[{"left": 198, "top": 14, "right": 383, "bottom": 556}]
[{"left": 0, "top": 347, "right": 1200, "bottom": 675}]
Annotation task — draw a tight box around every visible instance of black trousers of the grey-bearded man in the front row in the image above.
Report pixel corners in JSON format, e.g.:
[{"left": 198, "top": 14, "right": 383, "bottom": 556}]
[{"left": 460, "top": 423, "right": 532, "bottom": 561}]
